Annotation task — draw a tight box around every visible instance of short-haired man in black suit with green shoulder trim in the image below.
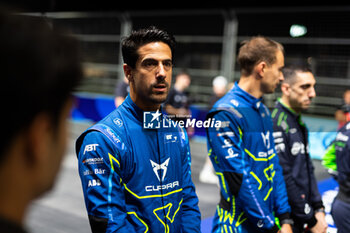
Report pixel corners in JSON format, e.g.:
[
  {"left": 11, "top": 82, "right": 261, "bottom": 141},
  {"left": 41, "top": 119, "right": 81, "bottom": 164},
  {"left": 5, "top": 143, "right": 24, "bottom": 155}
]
[{"left": 271, "top": 65, "right": 328, "bottom": 233}]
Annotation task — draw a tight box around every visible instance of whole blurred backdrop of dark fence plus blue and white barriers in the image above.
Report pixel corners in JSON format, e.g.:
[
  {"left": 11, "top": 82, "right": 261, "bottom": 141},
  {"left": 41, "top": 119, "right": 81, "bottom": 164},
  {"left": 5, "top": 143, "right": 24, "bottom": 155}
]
[{"left": 6, "top": 3, "right": 350, "bottom": 158}]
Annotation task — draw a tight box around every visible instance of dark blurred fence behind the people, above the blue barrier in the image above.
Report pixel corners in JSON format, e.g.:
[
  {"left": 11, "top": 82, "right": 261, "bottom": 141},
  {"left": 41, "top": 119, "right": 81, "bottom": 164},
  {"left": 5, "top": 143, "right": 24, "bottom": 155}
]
[{"left": 19, "top": 6, "right": 350, "bottom": 116}]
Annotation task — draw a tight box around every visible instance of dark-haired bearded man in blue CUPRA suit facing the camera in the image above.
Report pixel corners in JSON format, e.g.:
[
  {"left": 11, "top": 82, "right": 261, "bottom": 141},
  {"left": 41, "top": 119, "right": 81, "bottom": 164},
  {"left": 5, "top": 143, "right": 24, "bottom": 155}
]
[{"left": 76, "top": 27, "right": 201, "bottom": 233}]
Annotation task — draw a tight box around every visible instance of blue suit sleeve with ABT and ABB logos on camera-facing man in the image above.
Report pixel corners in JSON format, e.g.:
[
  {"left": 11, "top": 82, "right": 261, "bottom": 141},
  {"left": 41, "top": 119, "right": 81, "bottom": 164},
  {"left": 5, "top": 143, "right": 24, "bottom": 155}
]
[{"left": 76, "top": 108, "right": 138, "bottom": 233}]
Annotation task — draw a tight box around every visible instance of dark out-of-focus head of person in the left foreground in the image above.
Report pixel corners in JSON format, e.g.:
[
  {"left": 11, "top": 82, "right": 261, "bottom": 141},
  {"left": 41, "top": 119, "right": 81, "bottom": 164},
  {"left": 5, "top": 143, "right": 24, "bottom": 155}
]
[{"left": 0, "top": 10, "right": 82, "bottom": 233}]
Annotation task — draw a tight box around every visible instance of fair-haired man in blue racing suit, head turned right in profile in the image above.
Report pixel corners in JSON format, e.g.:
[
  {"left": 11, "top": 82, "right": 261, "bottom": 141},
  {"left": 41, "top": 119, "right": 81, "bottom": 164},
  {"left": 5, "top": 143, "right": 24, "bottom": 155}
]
[{"left": 207, "top": 36, "right": 293, "bottom": 233}]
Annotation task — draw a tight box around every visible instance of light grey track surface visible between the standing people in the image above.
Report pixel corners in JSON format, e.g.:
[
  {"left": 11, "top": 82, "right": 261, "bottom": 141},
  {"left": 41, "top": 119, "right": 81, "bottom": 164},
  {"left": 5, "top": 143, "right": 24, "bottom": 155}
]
[{"left": 26, "top": 122, "right": 328, "bottom": 233}]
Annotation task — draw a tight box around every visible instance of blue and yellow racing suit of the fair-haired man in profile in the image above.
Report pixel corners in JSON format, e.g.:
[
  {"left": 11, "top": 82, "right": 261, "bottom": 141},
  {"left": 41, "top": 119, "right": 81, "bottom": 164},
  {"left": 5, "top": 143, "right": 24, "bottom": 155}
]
[{"left": 207, "top": 83, "right": 290, "bottom": 233}]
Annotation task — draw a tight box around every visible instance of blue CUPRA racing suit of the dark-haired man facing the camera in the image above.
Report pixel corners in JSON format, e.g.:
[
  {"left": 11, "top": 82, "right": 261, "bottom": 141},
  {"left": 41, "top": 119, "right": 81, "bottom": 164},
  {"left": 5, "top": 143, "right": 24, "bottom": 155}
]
[{"left": 76, "top": 96, "right": 201, "bottom": 233}]
